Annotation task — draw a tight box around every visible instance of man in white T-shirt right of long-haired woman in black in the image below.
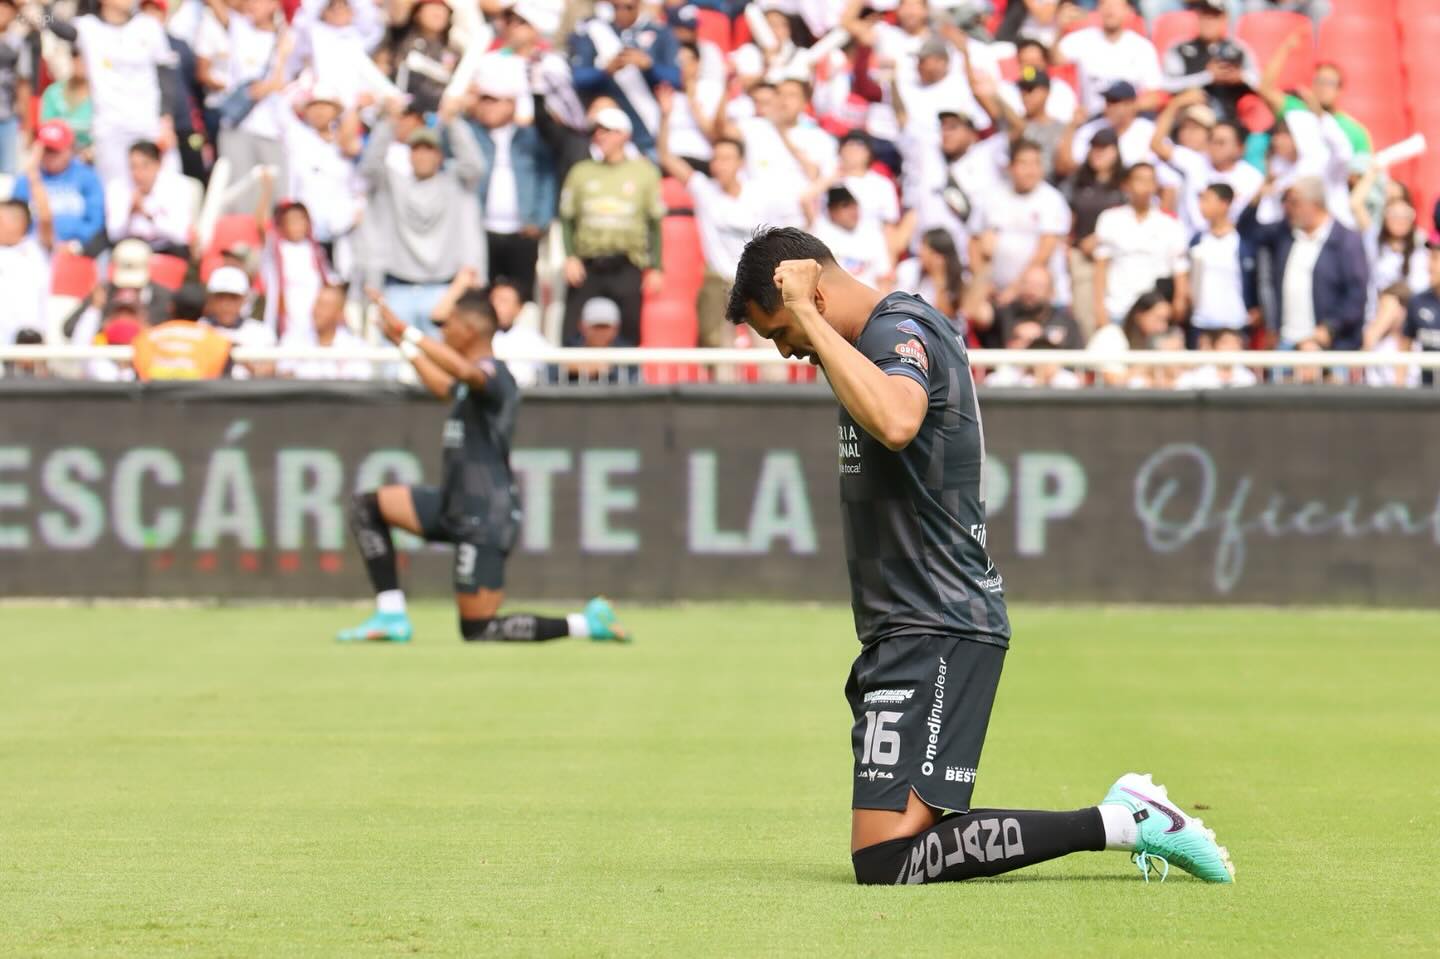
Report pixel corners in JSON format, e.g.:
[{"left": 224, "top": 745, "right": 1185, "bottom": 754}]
[{"left": 1094, "top": 163, "right": 1189, "bottom": 323}]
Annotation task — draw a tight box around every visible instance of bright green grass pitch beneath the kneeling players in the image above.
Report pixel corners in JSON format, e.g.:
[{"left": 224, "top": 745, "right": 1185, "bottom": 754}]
[{"left": 0, "top": 605, "right": 1440, "bottom": 959}]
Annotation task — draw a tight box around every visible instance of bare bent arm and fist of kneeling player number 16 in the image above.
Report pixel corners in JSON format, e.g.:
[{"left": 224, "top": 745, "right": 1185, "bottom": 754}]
[{"left": 775, "top": 259, "right": 929, "bottom": 449}]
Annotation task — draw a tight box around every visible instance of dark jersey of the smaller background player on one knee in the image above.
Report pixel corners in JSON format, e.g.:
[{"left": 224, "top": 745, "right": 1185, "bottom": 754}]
[{"left": 441, "top": 359, "right": 520, "bottom": 550}]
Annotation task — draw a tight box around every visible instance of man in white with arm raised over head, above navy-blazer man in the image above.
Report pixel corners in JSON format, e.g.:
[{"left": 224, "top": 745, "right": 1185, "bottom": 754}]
[{"left": 1151, "top": 89, "right": 1264, "bottom": 233}]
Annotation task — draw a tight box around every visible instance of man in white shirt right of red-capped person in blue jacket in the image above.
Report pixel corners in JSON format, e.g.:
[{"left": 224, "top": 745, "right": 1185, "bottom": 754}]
[{"left": 105, "top": 140, "right": 194, "bottom": 256}]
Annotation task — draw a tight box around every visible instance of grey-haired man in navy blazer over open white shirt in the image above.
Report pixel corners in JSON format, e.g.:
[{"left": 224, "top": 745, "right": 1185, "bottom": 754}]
[{"left": 1240, "top": 177, "right": 1369, "bottom": 350}]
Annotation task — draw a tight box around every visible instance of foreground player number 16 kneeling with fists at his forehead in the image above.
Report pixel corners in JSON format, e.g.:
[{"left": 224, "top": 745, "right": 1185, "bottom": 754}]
[{"left": 727, "top": 228, "right": 1234, "bottom": 883}]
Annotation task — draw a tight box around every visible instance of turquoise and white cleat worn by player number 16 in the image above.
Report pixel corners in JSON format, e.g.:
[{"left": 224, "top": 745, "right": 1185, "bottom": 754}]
[{"left": 1104, "top": 773, "right": 1236, "bottom": 883}]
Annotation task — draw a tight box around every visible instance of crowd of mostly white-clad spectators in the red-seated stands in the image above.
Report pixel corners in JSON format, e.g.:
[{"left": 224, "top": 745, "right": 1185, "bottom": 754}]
[{"left": 0, "top": 0, "right": 1440, "bottom": 386}]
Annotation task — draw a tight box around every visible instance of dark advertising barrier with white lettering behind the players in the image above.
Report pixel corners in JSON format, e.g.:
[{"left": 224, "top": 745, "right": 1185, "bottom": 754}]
[{"left": 0, "top": 380, "right": 1440, "bottom": 606}]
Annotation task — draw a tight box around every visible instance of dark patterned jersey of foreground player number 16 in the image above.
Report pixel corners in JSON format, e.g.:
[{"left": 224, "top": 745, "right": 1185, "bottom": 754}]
[{"left": 840, "top": 292, "right": 1009, "bottom": 647}]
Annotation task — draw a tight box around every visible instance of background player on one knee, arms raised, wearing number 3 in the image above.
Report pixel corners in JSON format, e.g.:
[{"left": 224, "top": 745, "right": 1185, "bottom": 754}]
[{"left": 338, "top": 283, "right": 625, "bottom": 642}]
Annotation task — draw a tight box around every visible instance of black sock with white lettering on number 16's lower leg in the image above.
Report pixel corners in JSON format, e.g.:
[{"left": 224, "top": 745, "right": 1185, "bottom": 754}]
[{"left": 850, "top": 806, "right": 1104, "bottom": 884}]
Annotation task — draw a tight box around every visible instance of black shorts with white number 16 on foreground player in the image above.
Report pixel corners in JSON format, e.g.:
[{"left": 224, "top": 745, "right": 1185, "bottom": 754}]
[{"left": 845, "top": 636, "right": 1005, "bottom": 812}]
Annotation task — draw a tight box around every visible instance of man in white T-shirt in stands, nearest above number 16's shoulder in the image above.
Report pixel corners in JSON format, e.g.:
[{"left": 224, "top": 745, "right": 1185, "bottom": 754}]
[{"left": 971, "top": 140, "right": 1070, "bottom": 304}]
